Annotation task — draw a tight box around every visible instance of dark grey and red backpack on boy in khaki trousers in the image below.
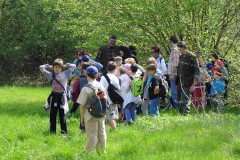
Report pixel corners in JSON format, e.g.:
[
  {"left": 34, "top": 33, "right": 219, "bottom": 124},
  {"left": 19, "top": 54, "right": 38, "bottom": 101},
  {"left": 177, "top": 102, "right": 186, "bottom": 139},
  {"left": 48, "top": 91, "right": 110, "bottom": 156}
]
[{"left": 85, "top": 84, "right": 107, "bottom": 118}]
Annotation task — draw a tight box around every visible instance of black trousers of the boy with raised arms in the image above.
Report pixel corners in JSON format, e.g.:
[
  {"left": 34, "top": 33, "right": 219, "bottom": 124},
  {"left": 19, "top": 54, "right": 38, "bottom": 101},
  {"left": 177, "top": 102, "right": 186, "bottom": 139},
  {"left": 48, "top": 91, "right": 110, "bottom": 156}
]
[{"left": 50, "top": 102, "right": 68, "bottom": 134}]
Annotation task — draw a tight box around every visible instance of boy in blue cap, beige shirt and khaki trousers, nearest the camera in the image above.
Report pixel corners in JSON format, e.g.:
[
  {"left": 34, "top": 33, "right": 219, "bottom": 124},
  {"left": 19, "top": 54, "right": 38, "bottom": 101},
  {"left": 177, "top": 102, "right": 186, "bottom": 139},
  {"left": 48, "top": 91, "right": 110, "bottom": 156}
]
[{"left": 77, "top": 66, "right": 107, "bottom": 151}]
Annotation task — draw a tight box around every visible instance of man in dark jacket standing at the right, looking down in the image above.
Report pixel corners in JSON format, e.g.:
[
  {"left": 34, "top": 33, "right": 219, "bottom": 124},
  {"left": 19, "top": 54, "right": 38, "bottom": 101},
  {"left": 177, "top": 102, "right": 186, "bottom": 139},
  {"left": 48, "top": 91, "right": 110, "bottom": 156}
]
[{"left": 176, "top": 41, "right": 200, "bottom": 116}]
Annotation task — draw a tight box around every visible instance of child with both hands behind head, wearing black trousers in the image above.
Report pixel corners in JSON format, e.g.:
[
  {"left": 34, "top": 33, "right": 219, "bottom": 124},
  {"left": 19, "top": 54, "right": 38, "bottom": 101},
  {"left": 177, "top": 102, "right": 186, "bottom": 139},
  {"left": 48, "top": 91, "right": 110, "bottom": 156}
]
[{"left": 39, "top": 58, "right": 76, "bottom": 134}]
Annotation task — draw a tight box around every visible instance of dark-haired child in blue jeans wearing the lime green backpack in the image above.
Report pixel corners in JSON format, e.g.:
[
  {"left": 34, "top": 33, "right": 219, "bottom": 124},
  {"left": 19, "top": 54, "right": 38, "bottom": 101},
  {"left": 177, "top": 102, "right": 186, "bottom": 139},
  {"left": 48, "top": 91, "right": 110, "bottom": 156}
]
[{"left": 123, "top": 64, "right": 141, "bottom": 124}]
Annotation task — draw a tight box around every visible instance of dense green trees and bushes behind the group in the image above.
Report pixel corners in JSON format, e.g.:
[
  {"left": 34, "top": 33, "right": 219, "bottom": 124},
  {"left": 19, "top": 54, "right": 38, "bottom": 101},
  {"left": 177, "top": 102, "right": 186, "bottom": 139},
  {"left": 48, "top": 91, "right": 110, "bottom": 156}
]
[{"left": 0, "top": 0, "right": 240, "bottom": 103}]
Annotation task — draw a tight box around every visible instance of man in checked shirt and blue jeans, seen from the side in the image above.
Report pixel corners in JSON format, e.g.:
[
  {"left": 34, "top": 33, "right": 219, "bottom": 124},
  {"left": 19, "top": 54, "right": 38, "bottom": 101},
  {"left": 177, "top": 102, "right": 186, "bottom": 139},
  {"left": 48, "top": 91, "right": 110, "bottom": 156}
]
[{"left": 168, "top": 36, "right": 180, "bottom": 109}]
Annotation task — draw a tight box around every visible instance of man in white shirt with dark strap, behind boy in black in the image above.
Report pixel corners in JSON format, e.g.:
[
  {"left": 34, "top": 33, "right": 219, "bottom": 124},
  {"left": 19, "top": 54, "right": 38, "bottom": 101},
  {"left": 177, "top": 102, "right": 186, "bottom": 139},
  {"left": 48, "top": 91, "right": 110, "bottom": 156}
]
[{"left": 151, "top": 46, "right": 167, "bottom": 76}]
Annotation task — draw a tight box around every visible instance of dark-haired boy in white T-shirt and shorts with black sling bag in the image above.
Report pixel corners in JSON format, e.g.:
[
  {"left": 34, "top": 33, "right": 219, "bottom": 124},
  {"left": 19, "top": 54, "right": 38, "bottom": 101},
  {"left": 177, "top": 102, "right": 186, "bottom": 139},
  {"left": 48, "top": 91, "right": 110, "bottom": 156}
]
[{"left": 100, "top": 61, "right": 120, "bottom": 130}]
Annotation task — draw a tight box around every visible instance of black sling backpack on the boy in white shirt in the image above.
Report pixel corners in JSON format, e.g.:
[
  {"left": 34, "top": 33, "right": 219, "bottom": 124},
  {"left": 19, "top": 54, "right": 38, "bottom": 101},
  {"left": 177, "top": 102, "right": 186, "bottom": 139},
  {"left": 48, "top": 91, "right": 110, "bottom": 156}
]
[{"left": 104, "top": 75, "right": 123, "bottom": 104}]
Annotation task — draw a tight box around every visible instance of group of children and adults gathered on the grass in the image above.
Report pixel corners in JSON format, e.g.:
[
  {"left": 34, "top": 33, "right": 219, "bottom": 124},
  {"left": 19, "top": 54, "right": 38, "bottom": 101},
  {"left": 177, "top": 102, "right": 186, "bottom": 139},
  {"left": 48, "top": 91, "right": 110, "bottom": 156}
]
[{"left": 39, "top": 35, "right": 229, "bottom": 150}]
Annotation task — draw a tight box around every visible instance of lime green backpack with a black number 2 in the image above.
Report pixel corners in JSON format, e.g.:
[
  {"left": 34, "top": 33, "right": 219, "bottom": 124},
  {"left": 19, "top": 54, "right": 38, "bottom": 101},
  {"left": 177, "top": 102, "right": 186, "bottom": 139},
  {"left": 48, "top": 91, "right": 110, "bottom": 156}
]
[{"left": 129, "top": 76, "right": 144, "bottom": 96}]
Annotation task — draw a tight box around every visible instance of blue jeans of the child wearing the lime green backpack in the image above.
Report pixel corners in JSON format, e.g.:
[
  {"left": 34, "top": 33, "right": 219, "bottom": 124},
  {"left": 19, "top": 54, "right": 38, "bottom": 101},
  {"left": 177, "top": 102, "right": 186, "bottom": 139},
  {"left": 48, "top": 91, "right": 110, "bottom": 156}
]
[{"left": 124, "top": 102, "right": 137, "bottom": 122}]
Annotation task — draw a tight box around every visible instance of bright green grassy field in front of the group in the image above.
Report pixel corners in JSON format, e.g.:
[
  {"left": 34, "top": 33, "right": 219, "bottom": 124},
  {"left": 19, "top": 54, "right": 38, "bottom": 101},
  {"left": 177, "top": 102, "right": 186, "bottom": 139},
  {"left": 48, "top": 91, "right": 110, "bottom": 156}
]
[{"left": 0, "top": 86, "right": 240, "bottom": 160}]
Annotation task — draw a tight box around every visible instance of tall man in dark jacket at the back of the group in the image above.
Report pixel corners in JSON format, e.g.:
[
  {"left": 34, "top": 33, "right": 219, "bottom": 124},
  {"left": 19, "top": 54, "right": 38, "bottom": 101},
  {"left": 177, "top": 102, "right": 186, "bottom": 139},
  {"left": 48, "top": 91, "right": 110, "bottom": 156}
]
[{"left": 95, "top": 35, "right": 119, "bottom": 74}]
